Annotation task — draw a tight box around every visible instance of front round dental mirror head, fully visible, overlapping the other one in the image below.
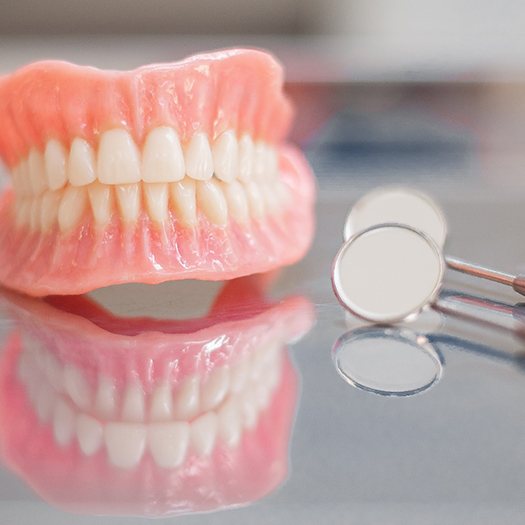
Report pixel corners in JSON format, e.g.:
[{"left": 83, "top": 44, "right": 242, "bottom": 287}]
[{"left": 332, "top": 224, "right": 444, "bottom": 323}]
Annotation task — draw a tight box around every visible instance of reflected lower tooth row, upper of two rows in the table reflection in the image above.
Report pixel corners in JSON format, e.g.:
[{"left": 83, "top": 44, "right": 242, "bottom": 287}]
[{"left": 18, "top": 345, "right": 281, "bottom": 423}]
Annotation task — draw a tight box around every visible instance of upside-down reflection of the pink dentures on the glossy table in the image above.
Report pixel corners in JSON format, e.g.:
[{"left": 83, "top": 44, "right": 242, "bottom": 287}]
[{"left": 0, "top": 279, "right": 312, "bottom": 515}]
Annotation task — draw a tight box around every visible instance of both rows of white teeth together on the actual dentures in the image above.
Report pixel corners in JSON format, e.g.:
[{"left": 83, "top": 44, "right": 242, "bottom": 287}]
[{"left": 12, "top": 126, "right": 286, "bottom": 232}]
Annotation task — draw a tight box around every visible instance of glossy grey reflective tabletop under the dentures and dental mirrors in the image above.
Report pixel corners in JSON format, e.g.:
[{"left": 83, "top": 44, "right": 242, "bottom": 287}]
[{"left": 0, "top": 72, "right": 525, "bottom": 525}]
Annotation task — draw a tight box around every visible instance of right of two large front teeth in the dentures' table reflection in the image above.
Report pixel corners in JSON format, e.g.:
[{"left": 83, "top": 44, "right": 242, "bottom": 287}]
[{"left": 148, "top": 422, "right": 190, "bottom": 468}]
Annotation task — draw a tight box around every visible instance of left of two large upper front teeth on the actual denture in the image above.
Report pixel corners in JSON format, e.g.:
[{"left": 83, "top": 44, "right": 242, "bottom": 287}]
[{"left": 97, "top": 129, "right": 141, "bottom": 184}]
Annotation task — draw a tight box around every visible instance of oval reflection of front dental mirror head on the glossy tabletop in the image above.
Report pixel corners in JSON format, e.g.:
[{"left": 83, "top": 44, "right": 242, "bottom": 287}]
[{"left": 333, "top": 327, "right": 443, "bottom": 396}]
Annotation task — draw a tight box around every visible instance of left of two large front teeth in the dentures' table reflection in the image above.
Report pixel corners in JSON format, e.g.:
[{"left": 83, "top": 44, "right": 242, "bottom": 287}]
[{"left": 104, "top": 423, "right": 147, "bottom": 469}]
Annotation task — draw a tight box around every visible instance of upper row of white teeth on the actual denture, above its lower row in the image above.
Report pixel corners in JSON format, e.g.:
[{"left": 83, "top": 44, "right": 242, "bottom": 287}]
[{"left": 13, "top": 126, "right": 278, "bottom": 195}]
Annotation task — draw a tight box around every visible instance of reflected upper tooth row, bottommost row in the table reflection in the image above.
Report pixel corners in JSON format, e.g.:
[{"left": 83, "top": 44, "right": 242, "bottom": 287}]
[{"left": 18, "top": 344, "right": 280, "bottom": 469}]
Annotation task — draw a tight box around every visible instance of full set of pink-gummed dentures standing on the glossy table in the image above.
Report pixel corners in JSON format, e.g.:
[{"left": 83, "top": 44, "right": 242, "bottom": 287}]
[{"left": 0, "top": 50, "right": 313, "bottom": 295}]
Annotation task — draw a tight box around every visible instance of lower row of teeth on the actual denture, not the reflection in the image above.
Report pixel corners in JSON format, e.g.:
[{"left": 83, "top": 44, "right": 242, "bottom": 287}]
[{"left": 16, "top": 177, "right": 286, "bottom": 231}]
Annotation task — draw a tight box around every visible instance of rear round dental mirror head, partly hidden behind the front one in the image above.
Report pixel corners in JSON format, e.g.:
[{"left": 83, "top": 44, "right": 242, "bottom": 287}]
[{"left": 344, "top": 187, "right": 447, "bottom": 248}]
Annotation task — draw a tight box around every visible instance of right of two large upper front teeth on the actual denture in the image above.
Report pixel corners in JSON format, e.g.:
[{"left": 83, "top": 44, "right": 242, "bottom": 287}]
[{"left": 142, "top": 126, "right": 185, "bottom": 182}]
